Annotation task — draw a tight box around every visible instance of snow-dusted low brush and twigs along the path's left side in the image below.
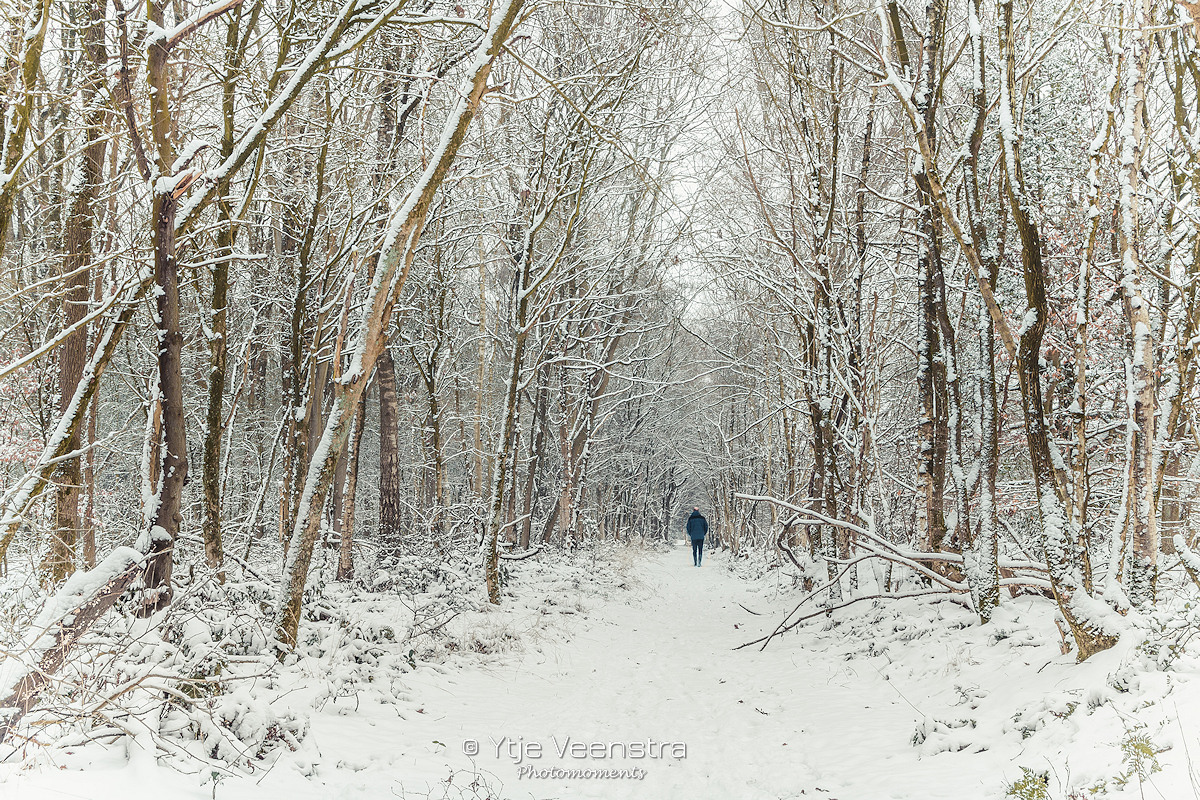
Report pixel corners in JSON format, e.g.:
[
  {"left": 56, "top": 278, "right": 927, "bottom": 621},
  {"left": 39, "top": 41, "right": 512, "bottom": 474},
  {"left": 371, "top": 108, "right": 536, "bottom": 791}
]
[{"left": 0, "top": 532, "right": 640, "bottom": 775}]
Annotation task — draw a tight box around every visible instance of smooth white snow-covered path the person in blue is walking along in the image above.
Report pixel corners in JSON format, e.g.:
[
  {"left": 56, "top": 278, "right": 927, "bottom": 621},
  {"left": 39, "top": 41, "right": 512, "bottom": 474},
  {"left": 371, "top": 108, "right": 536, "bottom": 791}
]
[{"left": 347, "top": 547, "right": 1000, "bottom": 800}]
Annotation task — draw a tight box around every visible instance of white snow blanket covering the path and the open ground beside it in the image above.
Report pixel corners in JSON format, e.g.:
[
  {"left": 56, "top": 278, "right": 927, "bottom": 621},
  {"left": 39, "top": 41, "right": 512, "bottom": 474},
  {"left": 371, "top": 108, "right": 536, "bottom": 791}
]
[{"left": 0, "top": 546, "right": 1200, "bottom": 800}]
